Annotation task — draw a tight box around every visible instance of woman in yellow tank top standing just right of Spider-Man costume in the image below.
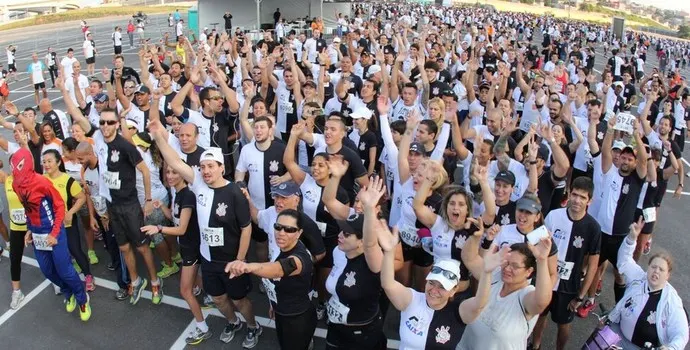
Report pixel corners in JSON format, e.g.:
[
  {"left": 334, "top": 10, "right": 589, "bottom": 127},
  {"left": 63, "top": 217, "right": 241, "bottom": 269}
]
[{"left": 43, "top": 149, "right": 96, "bottom": 292}]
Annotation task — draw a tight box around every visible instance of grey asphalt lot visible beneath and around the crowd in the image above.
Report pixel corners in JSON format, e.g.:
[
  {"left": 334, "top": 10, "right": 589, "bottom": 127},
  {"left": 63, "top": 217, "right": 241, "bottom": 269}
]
[{"left": 0, "top": 15, "right": 690, "bottom": 349}]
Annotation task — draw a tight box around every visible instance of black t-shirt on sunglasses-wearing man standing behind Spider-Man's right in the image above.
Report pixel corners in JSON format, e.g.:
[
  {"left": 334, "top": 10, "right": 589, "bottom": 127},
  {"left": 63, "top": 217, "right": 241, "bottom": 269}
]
[{"left": 101, "top": 134, "right": 143, "bottom": 206}]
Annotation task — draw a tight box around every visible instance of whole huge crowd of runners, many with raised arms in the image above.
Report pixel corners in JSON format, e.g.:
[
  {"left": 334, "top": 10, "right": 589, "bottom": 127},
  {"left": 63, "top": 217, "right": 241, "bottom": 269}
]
[{"left": 0, "top": 4, "right": 690, "bottom": 350}]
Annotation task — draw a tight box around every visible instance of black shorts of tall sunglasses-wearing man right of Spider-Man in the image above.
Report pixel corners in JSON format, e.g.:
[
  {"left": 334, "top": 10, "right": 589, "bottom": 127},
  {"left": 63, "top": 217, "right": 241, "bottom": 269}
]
[{"left": 108, "top": 203, "right": 149, "bottom": 247}]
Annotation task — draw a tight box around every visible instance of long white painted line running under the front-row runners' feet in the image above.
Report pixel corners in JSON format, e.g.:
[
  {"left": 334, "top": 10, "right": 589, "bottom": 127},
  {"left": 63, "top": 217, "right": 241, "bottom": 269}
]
[{"left": 0, "top": 251, "right": 400, "bottom": 349}]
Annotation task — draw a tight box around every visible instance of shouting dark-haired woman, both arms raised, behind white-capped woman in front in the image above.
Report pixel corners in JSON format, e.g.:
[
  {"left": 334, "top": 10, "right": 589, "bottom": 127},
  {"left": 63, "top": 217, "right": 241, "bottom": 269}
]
[{"left": 412, "top": 164, "right": 496, "bottom": 292}]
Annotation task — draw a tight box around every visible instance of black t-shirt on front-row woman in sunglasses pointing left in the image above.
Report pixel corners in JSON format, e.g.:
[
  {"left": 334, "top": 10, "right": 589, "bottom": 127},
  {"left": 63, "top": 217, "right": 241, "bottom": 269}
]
[{"left": 271, "top": 241, "right": 314, "bottom": 316}]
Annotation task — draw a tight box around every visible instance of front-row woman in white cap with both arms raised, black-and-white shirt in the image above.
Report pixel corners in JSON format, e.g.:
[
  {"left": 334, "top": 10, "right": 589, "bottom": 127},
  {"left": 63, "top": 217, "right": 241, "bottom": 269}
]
[{"left": 376, "top": 220, "right": 500, "bottom": 350}]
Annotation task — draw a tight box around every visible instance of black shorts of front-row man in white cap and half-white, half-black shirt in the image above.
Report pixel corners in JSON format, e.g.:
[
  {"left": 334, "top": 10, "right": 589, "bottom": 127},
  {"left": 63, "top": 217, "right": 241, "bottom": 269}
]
[{"left": 201, "top": 259, "right": 252, "bottom": 300}]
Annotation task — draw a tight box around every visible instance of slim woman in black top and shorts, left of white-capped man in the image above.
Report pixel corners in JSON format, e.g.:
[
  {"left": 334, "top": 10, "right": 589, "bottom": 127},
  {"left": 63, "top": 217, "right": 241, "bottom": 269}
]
[{"left": 141, "top": 166, "right": 207, "bottom": 345}]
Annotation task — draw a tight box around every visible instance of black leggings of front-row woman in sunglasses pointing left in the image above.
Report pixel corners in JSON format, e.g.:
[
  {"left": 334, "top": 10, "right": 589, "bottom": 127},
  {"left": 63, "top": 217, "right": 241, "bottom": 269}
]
[{"left": 275, "top": 304, "right": 316, "bottom": 350}]
